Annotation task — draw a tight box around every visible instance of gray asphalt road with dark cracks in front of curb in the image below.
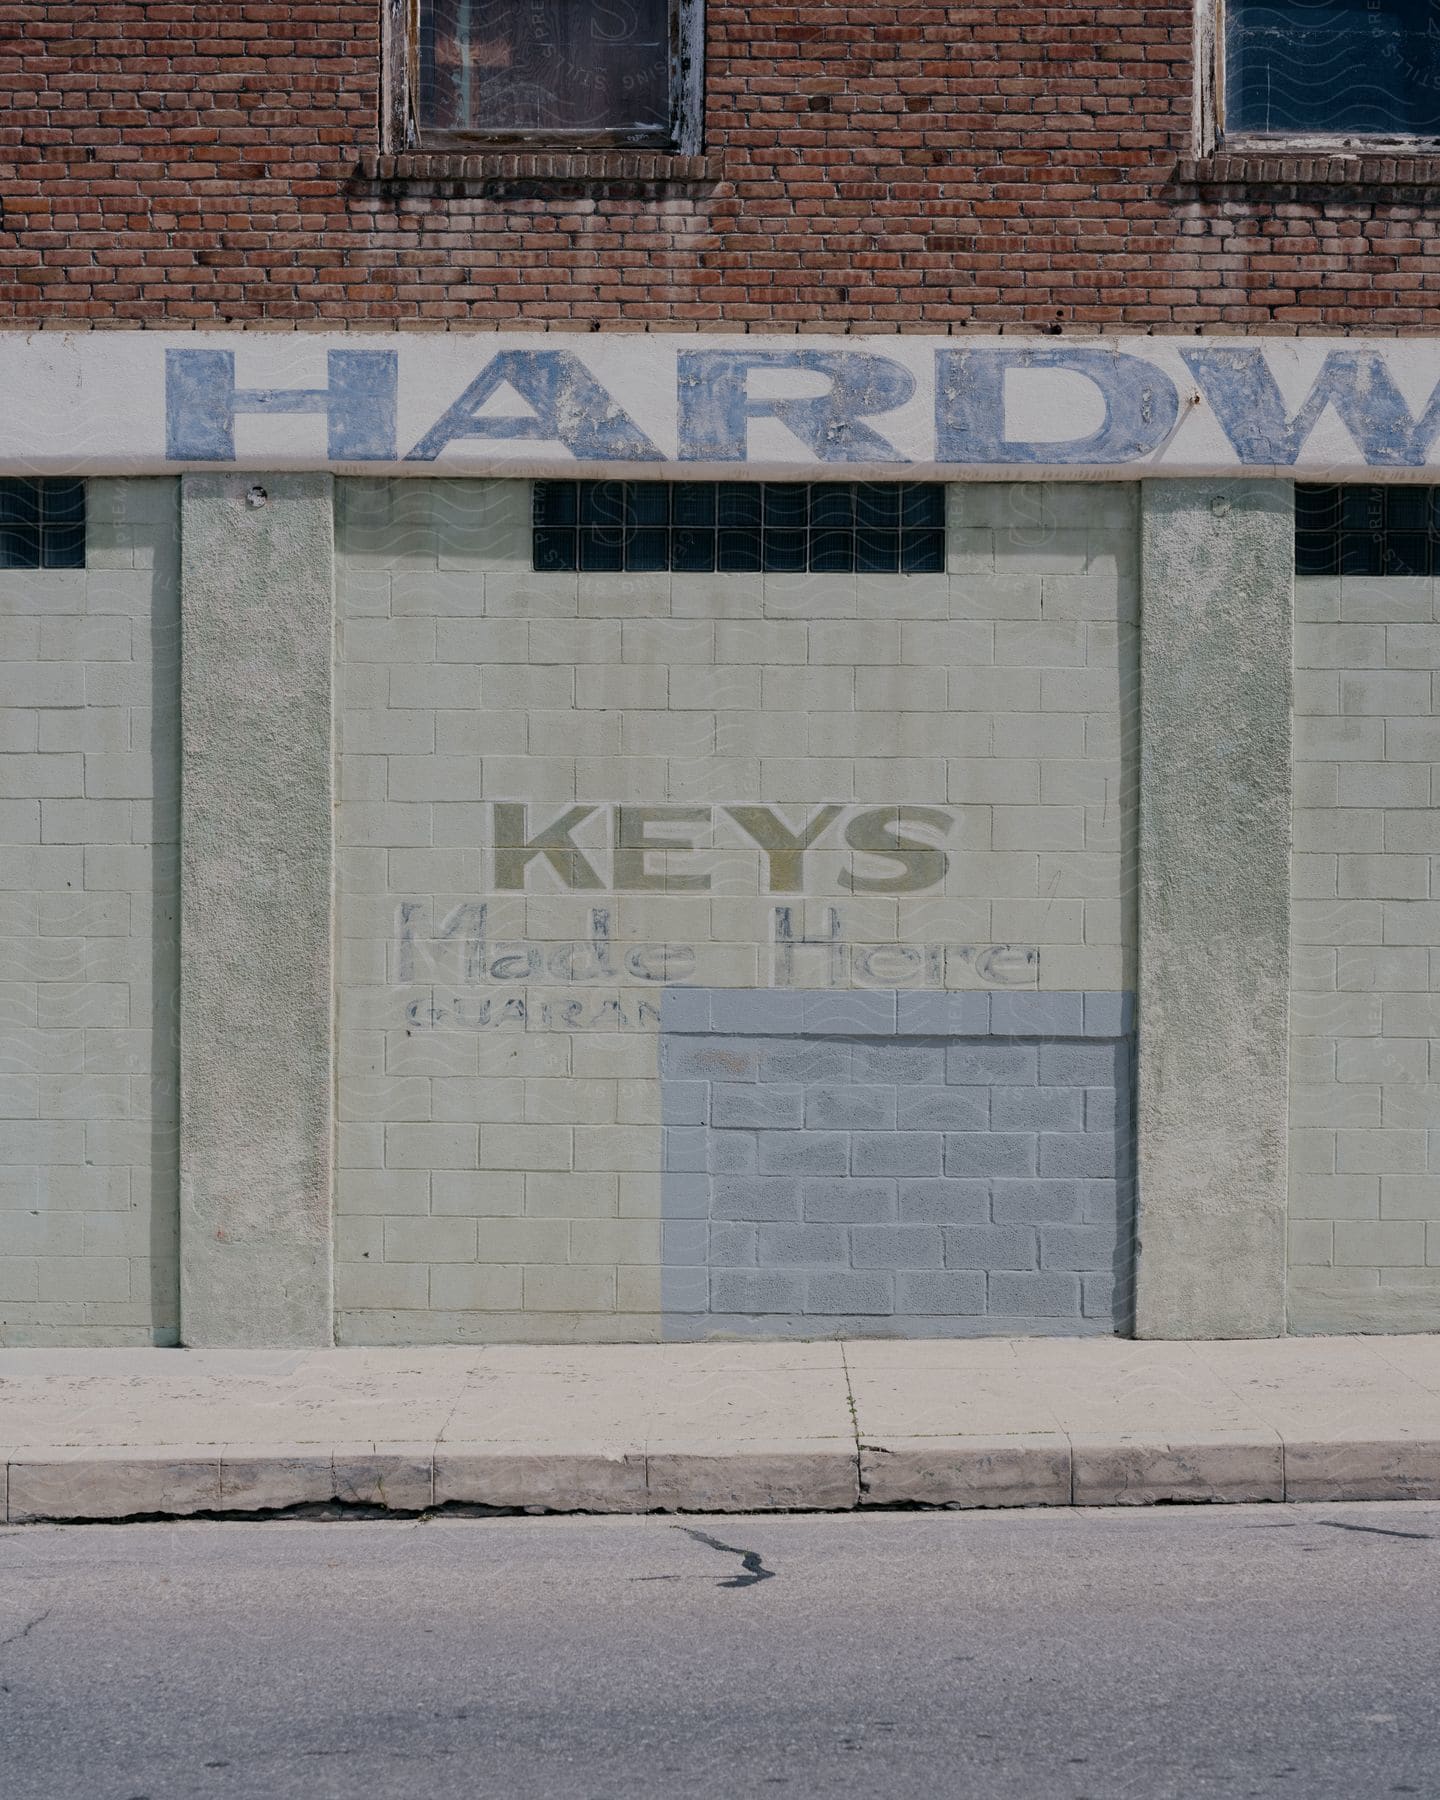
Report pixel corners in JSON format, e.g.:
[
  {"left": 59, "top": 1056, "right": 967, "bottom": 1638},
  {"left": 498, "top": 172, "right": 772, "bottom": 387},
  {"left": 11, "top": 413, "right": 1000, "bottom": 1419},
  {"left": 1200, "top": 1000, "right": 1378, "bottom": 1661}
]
[{"left": 0, "top": 1505, "right": 1440, "bottom": 1800}]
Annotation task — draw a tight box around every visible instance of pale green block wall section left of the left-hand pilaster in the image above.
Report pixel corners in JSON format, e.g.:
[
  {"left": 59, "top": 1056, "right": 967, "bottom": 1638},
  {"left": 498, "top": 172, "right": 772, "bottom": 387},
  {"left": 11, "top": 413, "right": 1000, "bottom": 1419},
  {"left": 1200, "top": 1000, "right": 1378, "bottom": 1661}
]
[{"left": 0, "top": 481, "right": 180, "bottom": 1345}]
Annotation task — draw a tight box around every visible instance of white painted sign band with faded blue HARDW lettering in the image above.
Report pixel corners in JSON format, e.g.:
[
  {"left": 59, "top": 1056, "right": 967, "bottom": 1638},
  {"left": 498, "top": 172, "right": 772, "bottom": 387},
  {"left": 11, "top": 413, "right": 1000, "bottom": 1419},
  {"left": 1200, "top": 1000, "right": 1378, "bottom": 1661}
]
[{"left": 0, "top": 331, "right": 1440, "bottom": 481}]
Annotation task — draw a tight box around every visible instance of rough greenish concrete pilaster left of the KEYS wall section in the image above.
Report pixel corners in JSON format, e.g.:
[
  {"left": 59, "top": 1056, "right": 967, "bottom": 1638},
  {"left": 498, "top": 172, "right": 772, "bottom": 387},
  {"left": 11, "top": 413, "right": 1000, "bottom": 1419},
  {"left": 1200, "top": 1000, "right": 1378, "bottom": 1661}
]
[{"left": 180, "top": 473, "right": 333, "bottom": 1345}]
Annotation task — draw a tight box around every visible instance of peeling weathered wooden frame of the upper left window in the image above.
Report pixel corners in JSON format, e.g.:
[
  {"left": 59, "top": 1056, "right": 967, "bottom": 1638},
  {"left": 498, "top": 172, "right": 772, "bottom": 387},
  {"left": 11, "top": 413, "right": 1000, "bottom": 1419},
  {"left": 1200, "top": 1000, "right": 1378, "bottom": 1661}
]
[{"left": 380, "top": 0, "right": 706, "bottom": 157}]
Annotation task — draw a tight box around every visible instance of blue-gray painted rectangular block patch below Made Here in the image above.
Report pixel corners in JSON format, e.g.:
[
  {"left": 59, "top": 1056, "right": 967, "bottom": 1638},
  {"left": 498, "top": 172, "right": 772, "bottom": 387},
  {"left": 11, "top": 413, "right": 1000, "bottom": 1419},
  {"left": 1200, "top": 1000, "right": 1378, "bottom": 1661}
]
[{"left": 661, "top": 988, "right": 1134, "bottom": 1337}]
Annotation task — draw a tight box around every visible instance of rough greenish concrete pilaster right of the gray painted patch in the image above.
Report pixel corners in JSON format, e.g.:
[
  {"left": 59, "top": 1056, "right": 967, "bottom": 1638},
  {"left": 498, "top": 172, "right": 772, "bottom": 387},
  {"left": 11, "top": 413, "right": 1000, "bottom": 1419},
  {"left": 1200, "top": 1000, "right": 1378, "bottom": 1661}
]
[{"left": 1136, "top": 481, "right": 1294, "bottom": 1337}]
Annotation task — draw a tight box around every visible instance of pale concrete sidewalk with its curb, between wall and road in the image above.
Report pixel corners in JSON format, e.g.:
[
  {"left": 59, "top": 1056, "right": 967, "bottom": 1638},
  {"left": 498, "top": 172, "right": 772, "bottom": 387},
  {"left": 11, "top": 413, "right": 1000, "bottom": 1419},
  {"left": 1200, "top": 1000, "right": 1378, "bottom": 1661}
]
[{"left": 0, "top": 1337, "right": 1440, "bottom": 1525}]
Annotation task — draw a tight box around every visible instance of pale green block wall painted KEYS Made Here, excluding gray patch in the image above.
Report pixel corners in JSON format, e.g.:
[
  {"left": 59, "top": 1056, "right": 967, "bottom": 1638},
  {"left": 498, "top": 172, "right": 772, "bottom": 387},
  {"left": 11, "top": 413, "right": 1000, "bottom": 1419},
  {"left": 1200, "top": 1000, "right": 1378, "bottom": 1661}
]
[{"left": 335, "top": 481, "right": 1136, "bottom": 1343}]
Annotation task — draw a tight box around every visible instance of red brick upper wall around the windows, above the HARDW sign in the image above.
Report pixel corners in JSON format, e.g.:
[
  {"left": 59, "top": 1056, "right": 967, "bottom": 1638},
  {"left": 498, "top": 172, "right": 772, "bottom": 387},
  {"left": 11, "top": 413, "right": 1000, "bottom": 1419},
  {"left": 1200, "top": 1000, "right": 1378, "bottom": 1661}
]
[{"left": 0, "top": 0, "right": 1440, "bottom": 331}]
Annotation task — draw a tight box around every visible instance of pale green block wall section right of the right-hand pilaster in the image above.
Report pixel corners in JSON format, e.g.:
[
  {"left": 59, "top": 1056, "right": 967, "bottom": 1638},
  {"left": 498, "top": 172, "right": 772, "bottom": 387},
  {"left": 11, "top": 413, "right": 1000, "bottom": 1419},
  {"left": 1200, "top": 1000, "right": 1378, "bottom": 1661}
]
[{"left": 1289, "top": 578, "right": 1440, "bottom": 1332}]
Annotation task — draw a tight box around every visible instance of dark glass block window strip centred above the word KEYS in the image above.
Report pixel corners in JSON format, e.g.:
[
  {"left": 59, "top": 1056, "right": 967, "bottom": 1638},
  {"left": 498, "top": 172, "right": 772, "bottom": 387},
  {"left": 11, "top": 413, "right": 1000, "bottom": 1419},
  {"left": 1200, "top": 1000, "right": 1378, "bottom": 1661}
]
[{"left": 535, "top": 481, "right": 945, "bottom": 574}]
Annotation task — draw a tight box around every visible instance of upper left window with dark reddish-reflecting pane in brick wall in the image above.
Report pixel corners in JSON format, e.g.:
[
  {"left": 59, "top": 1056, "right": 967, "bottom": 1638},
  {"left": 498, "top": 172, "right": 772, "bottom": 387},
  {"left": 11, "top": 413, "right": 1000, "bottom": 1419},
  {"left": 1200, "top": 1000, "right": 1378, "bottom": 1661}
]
[{"left": 403, "top": 0, "right": 702, "bottom": 151}]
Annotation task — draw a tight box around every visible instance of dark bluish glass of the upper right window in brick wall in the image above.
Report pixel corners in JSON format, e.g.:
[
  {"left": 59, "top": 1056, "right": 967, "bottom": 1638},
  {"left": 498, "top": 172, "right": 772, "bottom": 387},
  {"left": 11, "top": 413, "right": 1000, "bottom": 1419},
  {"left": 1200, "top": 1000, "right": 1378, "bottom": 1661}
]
[{"left": 1224, "top": 0, "right": 1440, "bottom": 137}]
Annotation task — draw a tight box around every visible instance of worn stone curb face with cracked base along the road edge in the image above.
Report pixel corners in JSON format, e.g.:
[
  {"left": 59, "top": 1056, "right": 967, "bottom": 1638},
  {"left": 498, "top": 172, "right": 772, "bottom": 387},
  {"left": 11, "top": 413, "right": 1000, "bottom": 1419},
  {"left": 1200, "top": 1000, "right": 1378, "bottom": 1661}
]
[{"left": 0, "top": 1431, "right": 1440, "bottom": 1525}]
